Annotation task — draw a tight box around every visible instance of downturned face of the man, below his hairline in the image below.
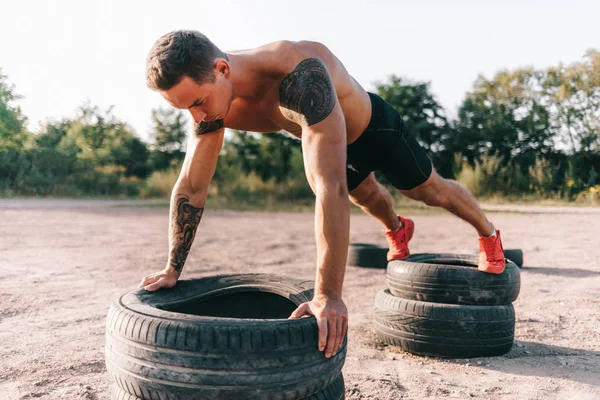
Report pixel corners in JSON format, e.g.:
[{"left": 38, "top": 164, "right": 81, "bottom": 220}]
[{"left": 160, "top": 61, "right": 233, "bottom": 124}]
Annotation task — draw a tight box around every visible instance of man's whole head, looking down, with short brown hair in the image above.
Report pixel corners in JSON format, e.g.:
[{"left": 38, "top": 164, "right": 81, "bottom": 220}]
[{"left": 146, "top": 30, "right": 233, "bottom": 123}]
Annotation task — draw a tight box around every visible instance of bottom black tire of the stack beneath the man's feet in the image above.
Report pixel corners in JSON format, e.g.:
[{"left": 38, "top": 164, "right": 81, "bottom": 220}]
[{"left": 375, "top": 289, "right": 515, "bottom": 358}]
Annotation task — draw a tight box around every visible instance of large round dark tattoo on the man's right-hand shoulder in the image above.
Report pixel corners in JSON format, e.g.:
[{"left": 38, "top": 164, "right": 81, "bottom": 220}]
[{"left": 279, "top": 58, "right": 336, "bottom": 126}]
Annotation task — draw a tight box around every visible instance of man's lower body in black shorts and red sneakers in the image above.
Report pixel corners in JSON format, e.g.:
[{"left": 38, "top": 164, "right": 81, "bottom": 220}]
[{"left": 348, "top": 91, "right": 504, "bottom": 273}]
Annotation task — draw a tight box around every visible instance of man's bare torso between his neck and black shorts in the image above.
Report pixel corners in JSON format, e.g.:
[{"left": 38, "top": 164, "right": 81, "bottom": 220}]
[{"left": 224, "top": 41, "right": 371, "bottom": 143}]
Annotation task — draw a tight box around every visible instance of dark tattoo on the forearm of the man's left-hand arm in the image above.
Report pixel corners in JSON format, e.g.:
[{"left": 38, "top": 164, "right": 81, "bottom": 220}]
[{"left": 169, "top": 195, "right": 204, "bottom": 273}]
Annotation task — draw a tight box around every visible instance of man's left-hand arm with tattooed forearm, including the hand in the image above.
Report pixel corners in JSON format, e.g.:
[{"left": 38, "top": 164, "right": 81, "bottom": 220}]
[{"left": 138, "top": 123, "right": 224, "bottom": 291}]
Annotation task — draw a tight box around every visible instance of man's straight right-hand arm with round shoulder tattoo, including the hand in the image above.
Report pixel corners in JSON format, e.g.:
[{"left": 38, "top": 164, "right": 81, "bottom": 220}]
[{"left": 279, "top": 58, "right": 350, "bottom": 357}]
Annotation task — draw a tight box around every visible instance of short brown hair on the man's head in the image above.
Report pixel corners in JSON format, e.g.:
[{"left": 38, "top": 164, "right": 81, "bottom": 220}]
[{"left": 146, "top": 30, "right": 229, "bottom": 90}]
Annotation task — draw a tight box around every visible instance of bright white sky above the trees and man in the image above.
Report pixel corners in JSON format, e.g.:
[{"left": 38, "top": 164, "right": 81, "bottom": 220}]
[{"left": 0, "top": 0, "right": 600, "bottom": 139}]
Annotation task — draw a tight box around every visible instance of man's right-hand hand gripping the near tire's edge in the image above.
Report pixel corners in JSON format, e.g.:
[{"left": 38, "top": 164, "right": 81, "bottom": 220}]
[{"left": 289, "top": 295, "right": 348, "bottom": 358}]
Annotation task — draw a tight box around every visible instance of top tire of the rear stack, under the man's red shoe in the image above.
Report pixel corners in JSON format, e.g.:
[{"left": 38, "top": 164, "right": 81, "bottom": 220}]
[{"left": 387, "top": 253, "right": 521, "bottom": 305}]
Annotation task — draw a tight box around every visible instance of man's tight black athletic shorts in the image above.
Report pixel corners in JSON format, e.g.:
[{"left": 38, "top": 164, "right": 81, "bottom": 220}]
[{"left": 346, "top": 93, "right": 433, "bottom": 191}]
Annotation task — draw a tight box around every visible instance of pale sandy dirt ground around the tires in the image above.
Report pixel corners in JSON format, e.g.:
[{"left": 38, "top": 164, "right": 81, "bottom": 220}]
[{"left": 0, "top": 200, "right": 600, "bottom": 400}]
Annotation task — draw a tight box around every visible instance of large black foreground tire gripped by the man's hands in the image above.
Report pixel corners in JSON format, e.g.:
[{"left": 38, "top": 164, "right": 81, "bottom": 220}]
[{"left": 106, "top": 274, "right": 347, "bottom": 400}]
